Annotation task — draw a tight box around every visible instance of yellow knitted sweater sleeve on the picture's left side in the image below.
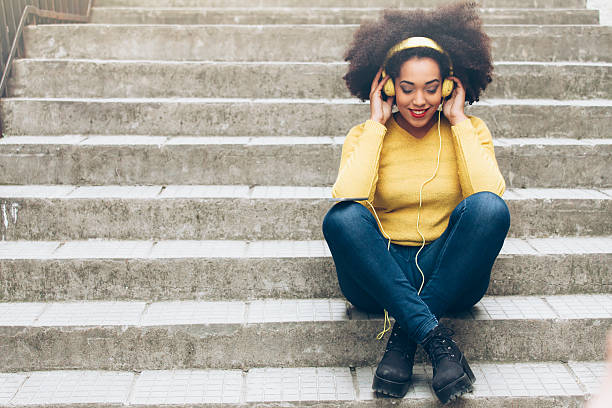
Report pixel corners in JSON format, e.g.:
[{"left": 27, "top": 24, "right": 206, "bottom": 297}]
[{"left": 332, "top": 120, "right": 387, "bottom": 202}]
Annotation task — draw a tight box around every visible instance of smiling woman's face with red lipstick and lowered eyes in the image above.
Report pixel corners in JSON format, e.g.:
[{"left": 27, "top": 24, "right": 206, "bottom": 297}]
[{"left": 395, "top": 57, "right": 442, "bottom": 128}]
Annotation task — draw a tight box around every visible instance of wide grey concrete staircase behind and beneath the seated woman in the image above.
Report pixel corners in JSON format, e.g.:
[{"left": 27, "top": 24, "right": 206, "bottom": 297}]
[{"left": 0, "top": 0, "right": 612, "bottom": 407}]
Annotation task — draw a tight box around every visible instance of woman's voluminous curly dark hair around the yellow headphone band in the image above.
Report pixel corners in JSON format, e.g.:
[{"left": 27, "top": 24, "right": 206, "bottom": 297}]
[{"left": 343, "top": 1, "right": 493, "bottom": 104}]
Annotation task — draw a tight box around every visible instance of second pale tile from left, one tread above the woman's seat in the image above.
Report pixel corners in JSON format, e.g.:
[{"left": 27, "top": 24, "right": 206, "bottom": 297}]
[{"left": 53, "top": 240, "right": 153, "bottom": 259}]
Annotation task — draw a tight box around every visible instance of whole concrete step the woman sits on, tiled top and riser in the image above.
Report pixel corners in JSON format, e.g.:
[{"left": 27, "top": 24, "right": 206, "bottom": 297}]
[{"left": 0, "top": 294, "right": 612, "bottom": 371}]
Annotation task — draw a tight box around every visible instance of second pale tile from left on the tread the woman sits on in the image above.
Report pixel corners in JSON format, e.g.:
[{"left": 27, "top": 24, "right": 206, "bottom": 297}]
[{"left": 34, "top": 302, "right": 145, "bottom": 326}]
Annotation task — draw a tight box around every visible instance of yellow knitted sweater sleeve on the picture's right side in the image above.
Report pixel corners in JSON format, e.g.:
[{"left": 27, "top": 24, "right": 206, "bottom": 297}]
[{"left": 451, "top": 116, "right": 506, "bottom": 197}]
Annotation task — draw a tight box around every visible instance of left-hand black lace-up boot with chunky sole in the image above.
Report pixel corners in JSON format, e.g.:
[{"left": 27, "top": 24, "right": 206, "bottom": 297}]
[{"left": 372, "top": 322, "right": 417, "bottom": 397}]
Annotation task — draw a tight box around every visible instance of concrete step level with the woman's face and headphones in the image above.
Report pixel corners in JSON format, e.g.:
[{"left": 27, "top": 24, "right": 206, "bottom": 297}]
[{"left": 8, "top": 59, "right": 612, "bottom": 99}]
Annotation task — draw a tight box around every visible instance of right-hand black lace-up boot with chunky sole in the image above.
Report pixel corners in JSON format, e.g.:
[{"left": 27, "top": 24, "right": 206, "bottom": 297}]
[{"left": 423, "top": 324, "right": 476, "bottom": 404}]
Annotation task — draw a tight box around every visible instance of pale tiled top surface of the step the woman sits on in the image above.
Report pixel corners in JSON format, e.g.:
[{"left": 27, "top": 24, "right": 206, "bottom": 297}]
[{"left": 0, "top": 294, "right": 612, "bottom": 327}]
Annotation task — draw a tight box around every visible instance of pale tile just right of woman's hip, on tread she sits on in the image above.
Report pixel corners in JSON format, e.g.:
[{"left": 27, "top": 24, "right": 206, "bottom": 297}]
[{"left": 471, "top": 296, "right": 557, "bottom": 320}]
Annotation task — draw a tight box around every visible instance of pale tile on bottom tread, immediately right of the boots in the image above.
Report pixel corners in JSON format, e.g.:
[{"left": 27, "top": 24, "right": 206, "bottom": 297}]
[{"left": 470, "top": 363, "right": 583, "bottom": 397}]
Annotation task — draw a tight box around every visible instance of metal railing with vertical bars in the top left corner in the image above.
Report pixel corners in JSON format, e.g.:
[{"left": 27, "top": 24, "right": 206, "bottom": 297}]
[{"left": 0, "top": 0, "right": 93, "bottom": 135}]
